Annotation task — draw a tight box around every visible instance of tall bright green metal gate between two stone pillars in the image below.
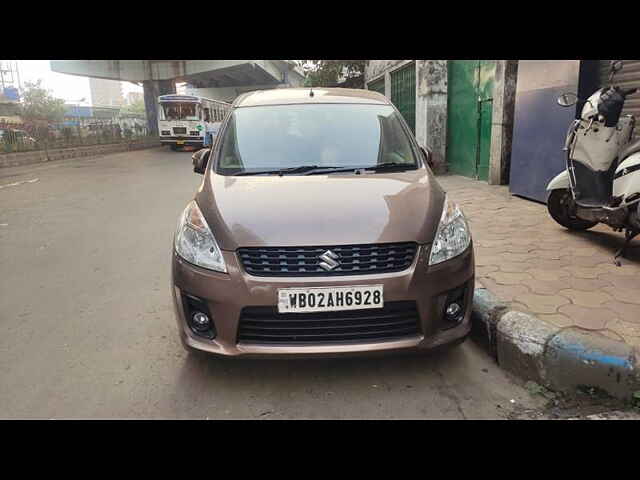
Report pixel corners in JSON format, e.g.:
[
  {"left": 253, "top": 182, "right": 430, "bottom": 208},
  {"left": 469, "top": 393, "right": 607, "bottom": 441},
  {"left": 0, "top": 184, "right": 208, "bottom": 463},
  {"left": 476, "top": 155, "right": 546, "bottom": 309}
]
[{"left": 447, "top": 60, "right": 496, "bottom": 180}]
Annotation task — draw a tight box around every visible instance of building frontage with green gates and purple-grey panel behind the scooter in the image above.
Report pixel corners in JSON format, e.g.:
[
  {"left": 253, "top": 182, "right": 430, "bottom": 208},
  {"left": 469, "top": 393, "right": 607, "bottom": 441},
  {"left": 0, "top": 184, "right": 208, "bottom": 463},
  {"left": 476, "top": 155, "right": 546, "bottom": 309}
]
[{"left": 365, "top": 60, "right": 640, "bottom": 193}]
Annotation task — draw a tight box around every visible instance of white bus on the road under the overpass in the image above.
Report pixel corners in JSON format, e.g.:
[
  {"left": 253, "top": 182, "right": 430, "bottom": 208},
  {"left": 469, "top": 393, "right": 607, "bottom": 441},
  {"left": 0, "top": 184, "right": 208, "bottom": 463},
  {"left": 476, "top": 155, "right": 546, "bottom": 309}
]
[{"left": 158, "top": 95, "right": 231, "bottom": 150}]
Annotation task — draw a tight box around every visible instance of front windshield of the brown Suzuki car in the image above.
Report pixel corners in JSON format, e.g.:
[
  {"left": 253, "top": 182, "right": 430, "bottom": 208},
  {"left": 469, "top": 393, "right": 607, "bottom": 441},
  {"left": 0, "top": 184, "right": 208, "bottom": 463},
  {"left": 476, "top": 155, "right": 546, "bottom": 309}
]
[{"left": 216, "top": 104, "right": 417, "bottom": 175}]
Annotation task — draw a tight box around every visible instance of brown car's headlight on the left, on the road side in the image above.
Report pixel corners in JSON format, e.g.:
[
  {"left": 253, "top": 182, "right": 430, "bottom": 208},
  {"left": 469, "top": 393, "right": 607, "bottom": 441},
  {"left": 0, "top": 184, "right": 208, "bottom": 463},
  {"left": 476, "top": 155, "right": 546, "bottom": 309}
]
[{"left": 174, "top": 200, "right": 227, "bottom": 273}]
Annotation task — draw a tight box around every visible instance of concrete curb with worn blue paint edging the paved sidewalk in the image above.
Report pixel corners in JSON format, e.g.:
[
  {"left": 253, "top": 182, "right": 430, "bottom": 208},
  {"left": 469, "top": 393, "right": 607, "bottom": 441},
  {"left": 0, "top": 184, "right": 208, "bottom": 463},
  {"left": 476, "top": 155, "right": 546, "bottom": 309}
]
[{"left": 471, "top": 288, "right": 640, "bottom": 401}]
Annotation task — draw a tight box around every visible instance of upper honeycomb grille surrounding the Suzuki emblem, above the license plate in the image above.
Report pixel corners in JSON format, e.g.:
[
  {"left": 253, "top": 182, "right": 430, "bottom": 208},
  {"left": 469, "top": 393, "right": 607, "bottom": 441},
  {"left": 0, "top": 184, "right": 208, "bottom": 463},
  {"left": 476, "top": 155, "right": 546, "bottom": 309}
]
[{"left": 238, "top": 242, "right": 417, "bottom": 277}]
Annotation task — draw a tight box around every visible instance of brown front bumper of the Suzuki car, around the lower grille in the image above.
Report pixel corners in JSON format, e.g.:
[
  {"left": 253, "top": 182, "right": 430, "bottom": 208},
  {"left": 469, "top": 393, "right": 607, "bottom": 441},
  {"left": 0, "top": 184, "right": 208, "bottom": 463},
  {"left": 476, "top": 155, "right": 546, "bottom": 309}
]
[{"left": 172, "top": 245, "right": 474, "bottom": 357}]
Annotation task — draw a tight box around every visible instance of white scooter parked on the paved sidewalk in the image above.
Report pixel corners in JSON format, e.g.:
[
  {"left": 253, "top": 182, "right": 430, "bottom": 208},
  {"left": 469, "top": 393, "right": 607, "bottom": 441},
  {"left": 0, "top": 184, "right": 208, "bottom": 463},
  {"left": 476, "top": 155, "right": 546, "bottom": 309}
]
[{"left": 547, "top": 60, "right": 640, "bottom": 266}]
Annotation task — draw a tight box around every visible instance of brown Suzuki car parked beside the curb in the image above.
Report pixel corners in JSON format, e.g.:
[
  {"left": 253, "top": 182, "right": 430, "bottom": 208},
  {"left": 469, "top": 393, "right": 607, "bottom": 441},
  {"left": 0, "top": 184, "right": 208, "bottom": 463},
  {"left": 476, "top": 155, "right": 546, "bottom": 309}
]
[{"left": 172, "top": 88, "right": 474, "bottom": 356}]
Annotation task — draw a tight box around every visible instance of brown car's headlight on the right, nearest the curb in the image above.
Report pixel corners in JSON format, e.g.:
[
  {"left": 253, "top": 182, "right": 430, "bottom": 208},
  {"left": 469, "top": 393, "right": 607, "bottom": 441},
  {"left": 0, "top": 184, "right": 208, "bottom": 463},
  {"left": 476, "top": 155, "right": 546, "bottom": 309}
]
[{"left": 429, "top": 196, "right": 471, "bottom": 265}]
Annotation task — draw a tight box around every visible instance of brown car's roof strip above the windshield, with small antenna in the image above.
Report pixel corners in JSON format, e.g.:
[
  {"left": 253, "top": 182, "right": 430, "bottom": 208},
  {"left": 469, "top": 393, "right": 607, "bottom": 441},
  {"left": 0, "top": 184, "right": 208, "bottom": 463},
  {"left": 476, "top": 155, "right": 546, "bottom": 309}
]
[{"left": 233, "top": 87, "right": 391, "bottom": 108}]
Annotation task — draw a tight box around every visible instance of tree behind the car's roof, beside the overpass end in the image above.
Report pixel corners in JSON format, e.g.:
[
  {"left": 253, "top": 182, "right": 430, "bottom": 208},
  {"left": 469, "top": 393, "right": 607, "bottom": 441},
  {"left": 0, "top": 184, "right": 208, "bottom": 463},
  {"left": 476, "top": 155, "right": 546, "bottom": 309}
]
[{"left": 297, "top": 60, "right": 367, "bottom": 88}]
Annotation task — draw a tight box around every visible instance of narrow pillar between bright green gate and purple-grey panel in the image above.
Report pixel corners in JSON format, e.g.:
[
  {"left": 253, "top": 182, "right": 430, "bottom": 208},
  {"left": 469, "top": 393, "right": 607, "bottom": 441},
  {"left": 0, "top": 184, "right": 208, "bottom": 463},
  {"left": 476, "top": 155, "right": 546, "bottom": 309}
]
[{"left": 489, "top": 60, "right": 518, "bottom": 185}]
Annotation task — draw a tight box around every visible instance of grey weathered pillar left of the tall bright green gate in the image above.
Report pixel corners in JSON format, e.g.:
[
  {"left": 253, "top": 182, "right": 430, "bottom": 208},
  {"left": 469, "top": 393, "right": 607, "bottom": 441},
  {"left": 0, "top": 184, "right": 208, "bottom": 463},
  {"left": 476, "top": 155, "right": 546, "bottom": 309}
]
[{"left": 416, "top": 60, "right": 448, "bottom": 173}]
